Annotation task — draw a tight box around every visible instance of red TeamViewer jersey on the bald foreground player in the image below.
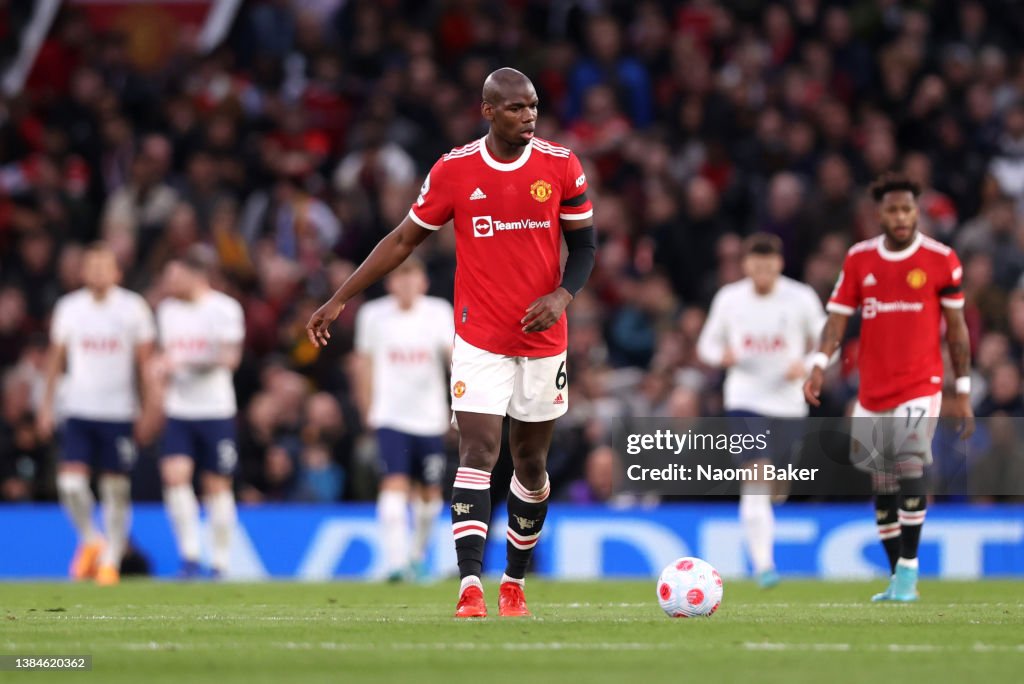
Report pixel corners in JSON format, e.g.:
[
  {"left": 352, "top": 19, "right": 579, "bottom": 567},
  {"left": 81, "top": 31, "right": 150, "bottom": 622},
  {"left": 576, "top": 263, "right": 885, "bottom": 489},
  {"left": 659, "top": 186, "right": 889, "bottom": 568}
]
[{"left": 409, "top": 138, "right": 594, "bottom": 357}]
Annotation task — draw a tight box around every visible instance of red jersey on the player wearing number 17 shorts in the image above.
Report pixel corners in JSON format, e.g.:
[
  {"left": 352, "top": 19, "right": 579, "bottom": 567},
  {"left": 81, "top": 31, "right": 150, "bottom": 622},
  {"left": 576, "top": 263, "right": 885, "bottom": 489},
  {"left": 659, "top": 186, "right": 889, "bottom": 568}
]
[{"left": 825, "top": 232, "right": 964, "bottom": 412}]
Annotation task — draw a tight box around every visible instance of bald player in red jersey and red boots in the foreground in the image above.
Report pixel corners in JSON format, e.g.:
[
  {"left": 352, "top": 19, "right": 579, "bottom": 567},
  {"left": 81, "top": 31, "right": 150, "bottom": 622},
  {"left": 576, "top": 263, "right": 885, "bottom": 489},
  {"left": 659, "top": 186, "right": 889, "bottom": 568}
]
[{"left": 306, "top": 69, "right": 596, "bottom": 617}]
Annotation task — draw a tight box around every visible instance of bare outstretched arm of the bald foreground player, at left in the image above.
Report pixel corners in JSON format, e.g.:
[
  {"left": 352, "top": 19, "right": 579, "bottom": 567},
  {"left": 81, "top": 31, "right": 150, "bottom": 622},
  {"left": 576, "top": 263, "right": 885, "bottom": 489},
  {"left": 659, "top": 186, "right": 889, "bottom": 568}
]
[{"left": 306, "top": 216, "right": 433, "bottom": 347}]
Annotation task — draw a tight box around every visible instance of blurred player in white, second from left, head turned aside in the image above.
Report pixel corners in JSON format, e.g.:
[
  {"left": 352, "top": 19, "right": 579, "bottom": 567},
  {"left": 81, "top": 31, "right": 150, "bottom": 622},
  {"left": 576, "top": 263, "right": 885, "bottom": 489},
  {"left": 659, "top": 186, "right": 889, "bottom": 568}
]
[{"left": 157, "top": 248, "right": 245, "bottom": 578}]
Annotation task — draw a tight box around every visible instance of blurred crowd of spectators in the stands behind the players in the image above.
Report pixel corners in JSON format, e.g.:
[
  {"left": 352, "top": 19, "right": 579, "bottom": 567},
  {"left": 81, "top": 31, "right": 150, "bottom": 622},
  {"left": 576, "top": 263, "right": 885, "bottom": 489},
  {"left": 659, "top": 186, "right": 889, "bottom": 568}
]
[{"left": 0, "top": 0, "right": 1024, "bottom": 502}]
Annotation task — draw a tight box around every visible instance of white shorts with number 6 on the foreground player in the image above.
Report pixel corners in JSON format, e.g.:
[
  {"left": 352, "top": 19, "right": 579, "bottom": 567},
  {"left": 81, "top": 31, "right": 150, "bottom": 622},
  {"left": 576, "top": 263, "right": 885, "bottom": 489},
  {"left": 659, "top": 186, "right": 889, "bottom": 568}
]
[{"left": 452, "top": 335, "right": 569, "bottom": 423}]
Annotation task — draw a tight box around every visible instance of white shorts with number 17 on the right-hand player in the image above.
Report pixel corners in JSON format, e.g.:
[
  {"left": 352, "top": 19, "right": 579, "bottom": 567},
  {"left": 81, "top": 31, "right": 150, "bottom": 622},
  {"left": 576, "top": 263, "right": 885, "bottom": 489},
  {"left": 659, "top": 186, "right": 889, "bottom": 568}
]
[{"left": 850, "top": 392, "right": 942, "bottom": 473}]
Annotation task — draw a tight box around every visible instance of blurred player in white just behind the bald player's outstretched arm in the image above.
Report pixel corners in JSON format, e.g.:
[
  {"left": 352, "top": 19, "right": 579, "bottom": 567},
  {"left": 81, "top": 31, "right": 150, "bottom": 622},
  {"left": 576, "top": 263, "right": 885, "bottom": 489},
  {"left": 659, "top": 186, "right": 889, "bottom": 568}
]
[{"left": 355, "top": 258, "right": 455, "bottom": 581}]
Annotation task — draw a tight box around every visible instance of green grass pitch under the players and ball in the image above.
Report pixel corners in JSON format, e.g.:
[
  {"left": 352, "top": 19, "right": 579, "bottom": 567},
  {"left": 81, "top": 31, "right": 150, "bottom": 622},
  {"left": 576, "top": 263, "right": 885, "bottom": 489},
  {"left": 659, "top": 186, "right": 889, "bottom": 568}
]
[{"left": 0, "top": 581, "right": 1024, "bottom": 684}]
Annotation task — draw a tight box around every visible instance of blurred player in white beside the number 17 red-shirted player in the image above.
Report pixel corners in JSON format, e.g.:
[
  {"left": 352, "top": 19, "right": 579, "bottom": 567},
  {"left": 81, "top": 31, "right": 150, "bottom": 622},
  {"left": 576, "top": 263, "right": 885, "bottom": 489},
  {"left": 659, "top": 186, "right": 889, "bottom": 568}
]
[{"left": 697, "top": 233, "right": 825, "bottom": 588}]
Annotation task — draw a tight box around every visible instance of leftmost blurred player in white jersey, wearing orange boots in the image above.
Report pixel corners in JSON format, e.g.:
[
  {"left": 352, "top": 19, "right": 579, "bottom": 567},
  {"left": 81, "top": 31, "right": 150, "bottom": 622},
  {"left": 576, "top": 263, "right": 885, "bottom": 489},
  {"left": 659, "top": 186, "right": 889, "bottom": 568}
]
[{"left": 38, "top": 244, "right": 159, "bottom": 585}]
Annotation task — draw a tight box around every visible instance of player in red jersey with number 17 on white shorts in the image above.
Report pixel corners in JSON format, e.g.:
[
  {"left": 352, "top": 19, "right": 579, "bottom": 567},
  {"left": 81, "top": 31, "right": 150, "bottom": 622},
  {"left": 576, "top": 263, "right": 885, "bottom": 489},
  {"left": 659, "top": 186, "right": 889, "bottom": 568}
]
[{"left": 804, "top": 174, "right": 974, "bottom": 601}]
